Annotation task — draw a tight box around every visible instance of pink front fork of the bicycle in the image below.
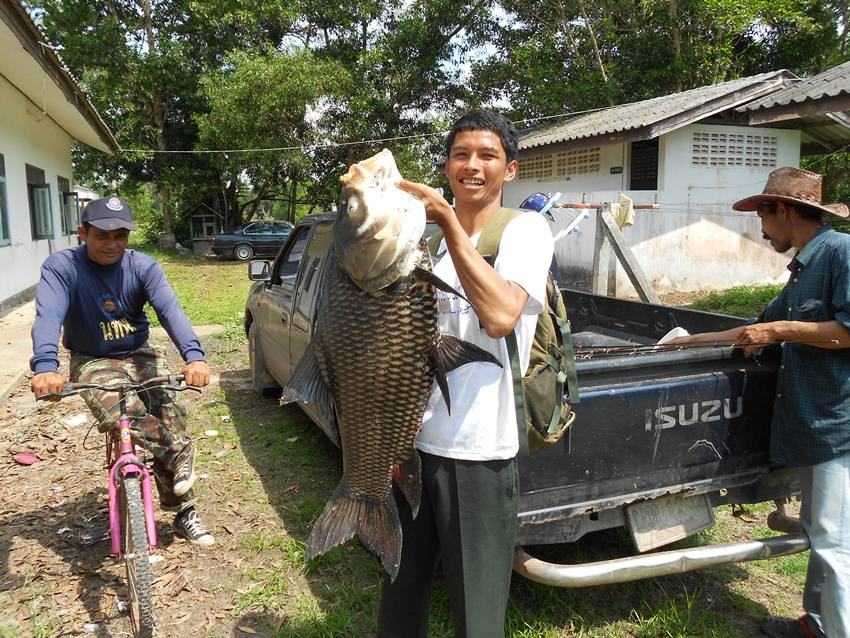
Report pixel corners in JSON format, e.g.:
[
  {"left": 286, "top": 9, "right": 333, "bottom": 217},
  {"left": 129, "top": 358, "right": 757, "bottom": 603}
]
[{"left": 107, "top": 402, "right": 156, "bottom": 556}]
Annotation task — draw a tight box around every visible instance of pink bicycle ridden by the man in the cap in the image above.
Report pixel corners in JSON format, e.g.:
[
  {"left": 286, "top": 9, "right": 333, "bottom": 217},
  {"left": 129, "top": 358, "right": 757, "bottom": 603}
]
[{"left": 36, "top": 374, "right": 201, "bottom": 638}]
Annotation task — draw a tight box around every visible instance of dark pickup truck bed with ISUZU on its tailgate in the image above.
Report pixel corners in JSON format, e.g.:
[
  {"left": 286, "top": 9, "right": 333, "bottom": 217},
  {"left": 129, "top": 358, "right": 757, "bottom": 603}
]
[{"left": 510, "top": 290, "right": 790, "bottom": 544}]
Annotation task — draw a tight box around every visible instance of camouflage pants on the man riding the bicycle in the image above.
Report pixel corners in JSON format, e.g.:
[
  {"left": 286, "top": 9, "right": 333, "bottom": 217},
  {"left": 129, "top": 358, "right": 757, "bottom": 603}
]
[{"left": 71, "top": 343, "right": 194, "bottom": 511}]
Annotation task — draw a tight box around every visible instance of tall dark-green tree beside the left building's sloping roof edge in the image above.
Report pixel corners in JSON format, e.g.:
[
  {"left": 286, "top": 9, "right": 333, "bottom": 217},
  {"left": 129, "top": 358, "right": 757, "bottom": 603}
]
[{"left": 30, "top": 0, "right": 298, "bottom": 241}]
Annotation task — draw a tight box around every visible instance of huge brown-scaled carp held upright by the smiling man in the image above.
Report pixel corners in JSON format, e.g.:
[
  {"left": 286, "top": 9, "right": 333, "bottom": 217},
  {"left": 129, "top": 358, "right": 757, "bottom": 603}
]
[{"left": 282, "top": 149, "right": 500, "bottom": 579}]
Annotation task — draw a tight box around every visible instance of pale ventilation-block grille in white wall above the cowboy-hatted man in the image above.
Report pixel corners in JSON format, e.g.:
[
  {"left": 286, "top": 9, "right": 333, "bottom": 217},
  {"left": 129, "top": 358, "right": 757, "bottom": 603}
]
[{"left": 691, "top": 131, "right": 779, "bottom": 168}]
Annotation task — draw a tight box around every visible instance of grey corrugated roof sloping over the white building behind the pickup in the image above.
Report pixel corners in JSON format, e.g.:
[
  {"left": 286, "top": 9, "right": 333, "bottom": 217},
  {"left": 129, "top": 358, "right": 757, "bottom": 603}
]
[{"left": 519, "top": 70, "right": 795, "bottom": 149}]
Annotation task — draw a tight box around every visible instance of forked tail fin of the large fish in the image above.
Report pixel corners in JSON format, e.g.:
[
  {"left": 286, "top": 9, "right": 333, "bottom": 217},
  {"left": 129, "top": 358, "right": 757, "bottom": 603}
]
[{"left": 304, "top": 483, "right": 401, "bottom": 580}]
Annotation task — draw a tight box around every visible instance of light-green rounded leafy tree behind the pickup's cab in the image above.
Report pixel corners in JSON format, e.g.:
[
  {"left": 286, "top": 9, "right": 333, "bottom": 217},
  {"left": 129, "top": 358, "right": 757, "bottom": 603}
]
[{"left": 196, "top": 48, "right": 348, "bottom": 222}]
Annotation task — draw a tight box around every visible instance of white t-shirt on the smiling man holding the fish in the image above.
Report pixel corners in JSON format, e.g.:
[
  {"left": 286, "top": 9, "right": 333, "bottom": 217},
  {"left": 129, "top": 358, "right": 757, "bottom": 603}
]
[{"left": 415, "top": 212, "right": 554, "bottom": 461}]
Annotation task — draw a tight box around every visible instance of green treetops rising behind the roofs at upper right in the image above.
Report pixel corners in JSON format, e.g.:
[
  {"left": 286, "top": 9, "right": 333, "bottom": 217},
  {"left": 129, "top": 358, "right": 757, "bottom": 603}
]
[{"left": 474, "top": 0, "right": 839, "bottom": 117}]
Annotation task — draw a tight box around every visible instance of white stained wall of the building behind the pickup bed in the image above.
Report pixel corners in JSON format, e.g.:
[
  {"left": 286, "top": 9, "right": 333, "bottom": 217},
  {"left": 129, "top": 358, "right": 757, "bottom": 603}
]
[{"left": 504, "top": 123, "right": 800, "bottom": 295}]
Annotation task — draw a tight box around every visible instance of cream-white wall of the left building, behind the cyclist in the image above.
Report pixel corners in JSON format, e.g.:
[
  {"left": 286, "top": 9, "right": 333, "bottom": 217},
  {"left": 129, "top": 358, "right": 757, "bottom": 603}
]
[{"left": 0, "top": 76, "right": 77, "bottom": 304}]
